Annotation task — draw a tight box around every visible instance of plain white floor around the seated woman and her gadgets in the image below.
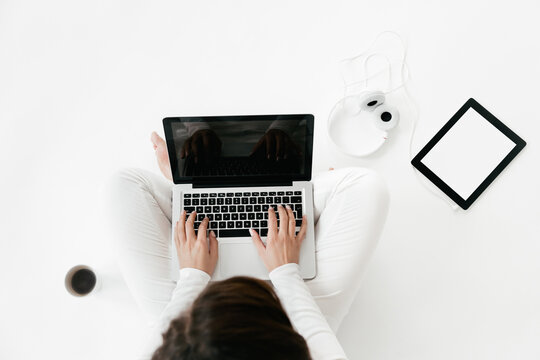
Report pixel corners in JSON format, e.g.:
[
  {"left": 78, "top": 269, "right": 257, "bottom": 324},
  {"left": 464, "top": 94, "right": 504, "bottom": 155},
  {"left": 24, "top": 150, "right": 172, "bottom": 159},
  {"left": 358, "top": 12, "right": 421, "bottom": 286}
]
[{"left": 0, "top": 0, "right": 540, "bottom": 360}]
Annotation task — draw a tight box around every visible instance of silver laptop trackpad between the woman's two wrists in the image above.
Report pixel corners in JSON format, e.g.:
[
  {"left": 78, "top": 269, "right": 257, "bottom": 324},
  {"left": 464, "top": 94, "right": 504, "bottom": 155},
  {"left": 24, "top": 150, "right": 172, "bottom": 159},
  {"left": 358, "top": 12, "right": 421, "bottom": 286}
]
[{"left": 219, "top": 242, "right": 268, "bottom": 279}]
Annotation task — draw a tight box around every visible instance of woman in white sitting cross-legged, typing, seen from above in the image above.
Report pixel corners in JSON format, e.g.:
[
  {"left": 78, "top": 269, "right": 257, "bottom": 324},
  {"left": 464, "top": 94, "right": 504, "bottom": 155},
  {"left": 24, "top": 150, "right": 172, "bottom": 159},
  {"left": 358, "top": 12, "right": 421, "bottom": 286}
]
[{"left": 105, "top": 133, "right": 388, "bottom": 360}]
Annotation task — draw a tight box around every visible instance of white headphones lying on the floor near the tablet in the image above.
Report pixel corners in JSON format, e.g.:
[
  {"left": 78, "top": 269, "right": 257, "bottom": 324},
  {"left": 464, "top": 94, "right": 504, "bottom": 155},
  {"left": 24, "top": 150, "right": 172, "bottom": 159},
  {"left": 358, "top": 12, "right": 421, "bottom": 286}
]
[{"left": 327, "top": 91, "right": 399, "bottom": 156}]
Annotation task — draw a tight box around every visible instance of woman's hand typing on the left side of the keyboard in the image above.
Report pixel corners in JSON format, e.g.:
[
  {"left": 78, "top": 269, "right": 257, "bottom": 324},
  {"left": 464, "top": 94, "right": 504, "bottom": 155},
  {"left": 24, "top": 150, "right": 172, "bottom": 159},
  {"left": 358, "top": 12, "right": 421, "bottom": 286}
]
[{"left": 174, "top": 210, "right": 218, "bottom": 276}]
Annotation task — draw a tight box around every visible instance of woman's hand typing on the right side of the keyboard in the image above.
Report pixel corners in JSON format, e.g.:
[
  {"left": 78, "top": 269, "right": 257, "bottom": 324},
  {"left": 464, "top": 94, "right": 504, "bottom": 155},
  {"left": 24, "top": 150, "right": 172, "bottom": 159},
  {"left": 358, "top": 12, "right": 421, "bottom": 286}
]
[{"left": 249, "top": 205, "right": 307, "bottom": 272}]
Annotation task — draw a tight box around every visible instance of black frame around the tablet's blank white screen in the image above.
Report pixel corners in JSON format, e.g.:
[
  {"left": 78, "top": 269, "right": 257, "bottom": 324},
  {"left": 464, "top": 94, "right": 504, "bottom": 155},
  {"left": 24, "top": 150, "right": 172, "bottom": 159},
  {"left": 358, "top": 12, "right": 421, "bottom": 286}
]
[{"left": 411, "top": 98, "right": 527, "bottom": 210}]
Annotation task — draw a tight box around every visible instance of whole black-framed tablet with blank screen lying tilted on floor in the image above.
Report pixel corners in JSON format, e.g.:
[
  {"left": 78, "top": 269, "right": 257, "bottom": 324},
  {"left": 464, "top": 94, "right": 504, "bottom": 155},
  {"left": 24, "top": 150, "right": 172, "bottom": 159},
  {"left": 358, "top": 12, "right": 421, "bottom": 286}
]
[{"left": 411, "top": 98, "right": 526, "bottom": 209}]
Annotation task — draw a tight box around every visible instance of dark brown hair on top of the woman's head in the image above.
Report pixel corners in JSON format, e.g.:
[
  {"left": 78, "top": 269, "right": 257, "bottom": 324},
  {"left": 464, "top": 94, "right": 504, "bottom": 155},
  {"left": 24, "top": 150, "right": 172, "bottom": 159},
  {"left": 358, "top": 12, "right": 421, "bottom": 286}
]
[{"left": 152, "top": 277, "right": 311, "bottom": 360}]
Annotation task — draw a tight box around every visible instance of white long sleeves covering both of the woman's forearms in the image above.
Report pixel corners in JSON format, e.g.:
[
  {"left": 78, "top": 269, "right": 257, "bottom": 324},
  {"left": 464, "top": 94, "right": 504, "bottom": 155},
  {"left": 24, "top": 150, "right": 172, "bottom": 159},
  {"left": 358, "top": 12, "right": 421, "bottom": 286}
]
[{"left": 144, "top": 263, "right": 347, "bottom": 360}]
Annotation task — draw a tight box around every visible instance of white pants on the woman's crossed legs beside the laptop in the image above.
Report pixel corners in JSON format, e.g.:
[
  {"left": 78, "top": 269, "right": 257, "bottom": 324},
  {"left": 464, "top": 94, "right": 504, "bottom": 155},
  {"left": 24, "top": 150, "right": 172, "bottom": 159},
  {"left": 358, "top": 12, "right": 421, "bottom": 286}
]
[{"left": 107, "top": 168, "right": 388, "bottom": 331}]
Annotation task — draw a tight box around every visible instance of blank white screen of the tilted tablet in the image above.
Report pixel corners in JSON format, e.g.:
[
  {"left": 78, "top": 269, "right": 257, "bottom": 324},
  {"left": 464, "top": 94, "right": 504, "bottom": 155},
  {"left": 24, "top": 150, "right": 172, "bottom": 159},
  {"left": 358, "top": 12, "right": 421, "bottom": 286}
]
[{"left": 422, "top": 108, "right": 516, "bottom": 200}]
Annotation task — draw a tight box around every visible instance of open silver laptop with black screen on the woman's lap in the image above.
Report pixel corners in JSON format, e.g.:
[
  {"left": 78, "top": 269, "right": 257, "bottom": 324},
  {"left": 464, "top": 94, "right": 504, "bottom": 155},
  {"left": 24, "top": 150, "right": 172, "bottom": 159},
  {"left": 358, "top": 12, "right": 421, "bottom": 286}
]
[{"left": 163, "top": 114, "right": 316, "bottom": 280}]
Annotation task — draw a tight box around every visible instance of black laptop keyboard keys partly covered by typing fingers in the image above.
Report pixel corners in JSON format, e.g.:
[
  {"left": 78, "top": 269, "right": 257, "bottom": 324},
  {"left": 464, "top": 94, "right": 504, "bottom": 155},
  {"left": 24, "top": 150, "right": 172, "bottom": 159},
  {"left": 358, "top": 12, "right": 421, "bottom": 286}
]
[{"left": 183, "top": 190, "right": 303, "bottom": 238}]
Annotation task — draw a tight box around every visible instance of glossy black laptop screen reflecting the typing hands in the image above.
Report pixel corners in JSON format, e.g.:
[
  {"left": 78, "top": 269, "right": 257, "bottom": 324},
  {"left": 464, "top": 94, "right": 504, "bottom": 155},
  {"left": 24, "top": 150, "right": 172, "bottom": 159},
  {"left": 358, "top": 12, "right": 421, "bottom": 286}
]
[{"left": 163, "top": 114, "right": 313, "bottom": 185}]
